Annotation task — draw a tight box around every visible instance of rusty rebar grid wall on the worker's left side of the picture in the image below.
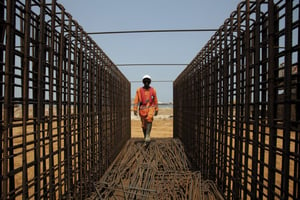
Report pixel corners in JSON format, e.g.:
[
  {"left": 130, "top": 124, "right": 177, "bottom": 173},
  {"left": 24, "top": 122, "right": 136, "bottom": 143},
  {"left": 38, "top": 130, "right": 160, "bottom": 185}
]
[{"left": 0, "top": 0, "right": 130, "bottom": 199}]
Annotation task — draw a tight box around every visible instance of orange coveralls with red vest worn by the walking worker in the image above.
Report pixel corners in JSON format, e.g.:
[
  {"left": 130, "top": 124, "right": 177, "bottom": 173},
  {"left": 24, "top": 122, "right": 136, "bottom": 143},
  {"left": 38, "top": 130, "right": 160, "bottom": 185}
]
[{"left": 133, "top": 87, "right": 158, "bottom": 129}]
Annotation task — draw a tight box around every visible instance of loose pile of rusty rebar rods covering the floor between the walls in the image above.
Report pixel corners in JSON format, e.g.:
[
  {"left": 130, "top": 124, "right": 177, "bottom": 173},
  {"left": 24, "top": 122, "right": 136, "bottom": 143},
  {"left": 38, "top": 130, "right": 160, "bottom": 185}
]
[{"left": 89, "top": 139, "right": 223, "bottom": 199}]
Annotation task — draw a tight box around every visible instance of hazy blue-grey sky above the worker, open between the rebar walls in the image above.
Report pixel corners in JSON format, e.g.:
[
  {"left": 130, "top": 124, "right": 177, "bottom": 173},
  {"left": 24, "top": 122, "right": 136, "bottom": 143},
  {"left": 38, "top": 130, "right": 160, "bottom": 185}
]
[{"left": 57, "top": 0, "right": 241, "bottom": 102}]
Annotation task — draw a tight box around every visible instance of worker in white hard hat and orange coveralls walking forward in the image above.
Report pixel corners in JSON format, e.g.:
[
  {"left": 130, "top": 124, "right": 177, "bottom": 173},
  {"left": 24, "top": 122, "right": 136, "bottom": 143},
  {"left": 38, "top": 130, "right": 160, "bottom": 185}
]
[{"left": 133, "top": 75, "right": 158, "bottom": 143}]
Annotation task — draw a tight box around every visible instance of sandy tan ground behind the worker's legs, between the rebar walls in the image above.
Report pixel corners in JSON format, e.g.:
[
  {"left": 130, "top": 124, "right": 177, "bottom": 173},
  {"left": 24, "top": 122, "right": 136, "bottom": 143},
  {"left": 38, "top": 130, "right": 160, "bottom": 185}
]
[{"left": 131, "top": 108, "right": 173, "bottom": 138}]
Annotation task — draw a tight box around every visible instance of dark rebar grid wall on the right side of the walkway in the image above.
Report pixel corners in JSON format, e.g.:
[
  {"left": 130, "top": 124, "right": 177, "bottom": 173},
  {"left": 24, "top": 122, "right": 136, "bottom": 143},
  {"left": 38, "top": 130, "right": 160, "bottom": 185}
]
[{"left": 174, "top": 0, "right": 300, "bottom": 199}]
